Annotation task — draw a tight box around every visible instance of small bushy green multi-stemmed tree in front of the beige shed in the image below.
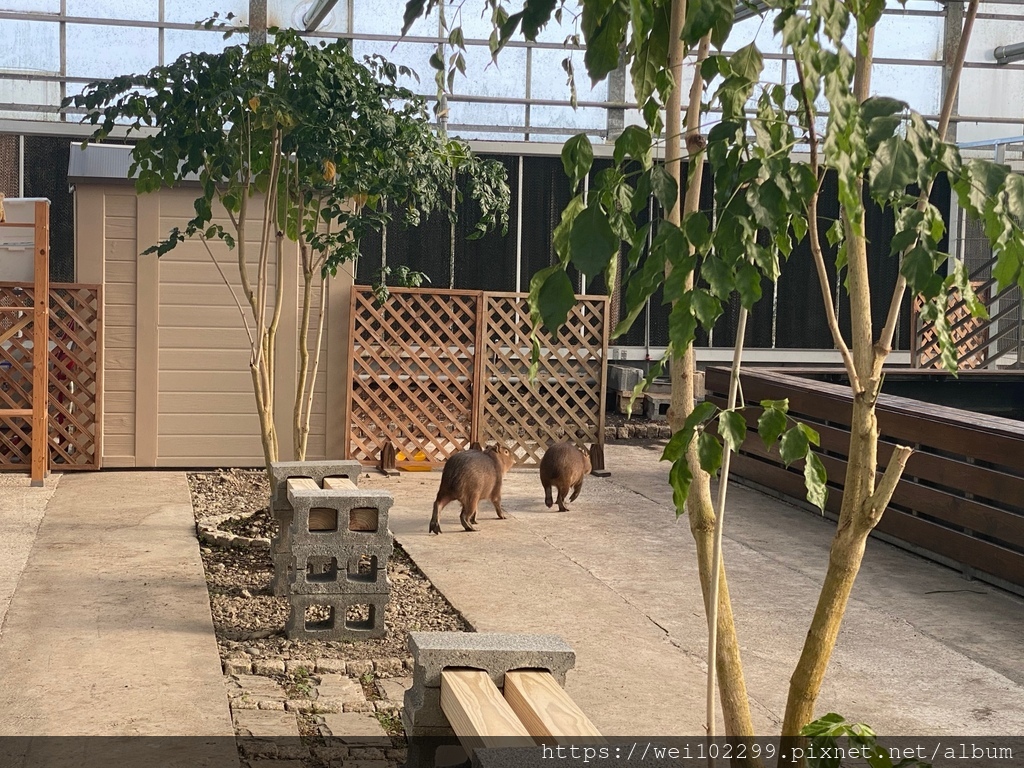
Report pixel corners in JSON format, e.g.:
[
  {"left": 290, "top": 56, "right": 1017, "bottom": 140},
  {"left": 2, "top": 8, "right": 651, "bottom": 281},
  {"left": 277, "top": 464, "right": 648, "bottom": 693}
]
[{"left": 66, "top": 16, "right": 510, "bottom": 468}]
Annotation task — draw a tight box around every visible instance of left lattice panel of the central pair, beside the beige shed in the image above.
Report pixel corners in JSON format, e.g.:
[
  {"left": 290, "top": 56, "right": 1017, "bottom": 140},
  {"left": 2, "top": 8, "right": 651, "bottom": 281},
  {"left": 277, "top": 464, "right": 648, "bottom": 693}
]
[{"left": 346, "top": 288, "right": 479, "bottom": 466}]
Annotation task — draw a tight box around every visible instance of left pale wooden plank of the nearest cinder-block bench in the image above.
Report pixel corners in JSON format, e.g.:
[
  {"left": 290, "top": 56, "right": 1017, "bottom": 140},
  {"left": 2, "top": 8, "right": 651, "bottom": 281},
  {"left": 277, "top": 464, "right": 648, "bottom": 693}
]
[{"left": 441, "top": 669, "right": 537, "bottom": 751}]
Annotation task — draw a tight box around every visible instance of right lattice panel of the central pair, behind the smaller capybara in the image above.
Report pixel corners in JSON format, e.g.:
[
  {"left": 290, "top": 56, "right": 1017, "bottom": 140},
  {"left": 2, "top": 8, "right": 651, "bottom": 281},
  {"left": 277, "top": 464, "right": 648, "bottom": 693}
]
[{"left": 478, "top": 294, "right": 607, "bottom": 465}]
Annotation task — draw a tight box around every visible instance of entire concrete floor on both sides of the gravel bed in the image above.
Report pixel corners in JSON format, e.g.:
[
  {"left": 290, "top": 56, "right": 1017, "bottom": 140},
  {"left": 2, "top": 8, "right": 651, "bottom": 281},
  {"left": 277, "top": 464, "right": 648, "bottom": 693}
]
[{"left": 0, "top": 445, "right": 1024, "bottom": 745}]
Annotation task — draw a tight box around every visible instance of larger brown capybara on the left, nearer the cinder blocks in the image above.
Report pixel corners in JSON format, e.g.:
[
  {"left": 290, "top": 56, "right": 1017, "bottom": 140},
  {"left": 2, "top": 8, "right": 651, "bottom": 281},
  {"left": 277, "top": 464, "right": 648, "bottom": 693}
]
[{"left": 430, "top": 445, "right": 515, "bottom": 534}]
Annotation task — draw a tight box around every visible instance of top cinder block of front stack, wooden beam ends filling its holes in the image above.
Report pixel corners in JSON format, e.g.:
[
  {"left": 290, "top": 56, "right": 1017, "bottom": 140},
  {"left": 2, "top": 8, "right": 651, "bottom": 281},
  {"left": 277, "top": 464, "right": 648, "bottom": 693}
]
[{"left": 288, "top": 489, "right": 394, "bottom": 551}]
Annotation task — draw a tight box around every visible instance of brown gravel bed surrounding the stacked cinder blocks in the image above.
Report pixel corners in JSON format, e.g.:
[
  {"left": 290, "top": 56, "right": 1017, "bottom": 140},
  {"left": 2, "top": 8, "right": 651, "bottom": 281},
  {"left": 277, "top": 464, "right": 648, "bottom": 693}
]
[{"left": 188, "top": 469, "right": 471, "bottom": 662}]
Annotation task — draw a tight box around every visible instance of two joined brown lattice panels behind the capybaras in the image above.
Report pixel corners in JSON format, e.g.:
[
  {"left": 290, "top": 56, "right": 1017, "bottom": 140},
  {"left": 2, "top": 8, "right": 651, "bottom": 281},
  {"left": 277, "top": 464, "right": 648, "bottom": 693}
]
[{"left": 345, "top": 287, "right": 608, "bottom": 467}]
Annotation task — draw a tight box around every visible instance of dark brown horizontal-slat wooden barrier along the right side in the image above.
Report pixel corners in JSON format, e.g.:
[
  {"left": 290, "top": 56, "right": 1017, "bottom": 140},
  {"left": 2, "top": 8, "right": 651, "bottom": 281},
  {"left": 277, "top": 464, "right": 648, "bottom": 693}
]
[{"left": 706, "top": 368, "right": 1024, "bottom": 592}]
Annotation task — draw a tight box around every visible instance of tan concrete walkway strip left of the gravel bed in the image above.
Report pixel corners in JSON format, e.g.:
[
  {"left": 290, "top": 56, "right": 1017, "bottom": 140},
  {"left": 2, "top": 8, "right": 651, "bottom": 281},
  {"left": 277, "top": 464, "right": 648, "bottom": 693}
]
[{"left": 0, "top": 472, "right": 238, "bottom": 765}]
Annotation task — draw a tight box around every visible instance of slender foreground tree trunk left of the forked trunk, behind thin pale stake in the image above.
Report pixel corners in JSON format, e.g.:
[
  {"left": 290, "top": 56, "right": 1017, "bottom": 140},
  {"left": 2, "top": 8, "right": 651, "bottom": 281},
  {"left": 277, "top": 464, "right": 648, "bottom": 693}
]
[{"left": 665, "top": 0, "right": 756, "bottom": 749}]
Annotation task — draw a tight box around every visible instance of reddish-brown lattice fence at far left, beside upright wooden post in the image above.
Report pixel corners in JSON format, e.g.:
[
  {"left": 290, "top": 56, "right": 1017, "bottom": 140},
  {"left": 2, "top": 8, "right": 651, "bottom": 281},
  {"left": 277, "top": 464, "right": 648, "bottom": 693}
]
[{"left": 0, "top": 283, "right": 102, "bottom": 470}]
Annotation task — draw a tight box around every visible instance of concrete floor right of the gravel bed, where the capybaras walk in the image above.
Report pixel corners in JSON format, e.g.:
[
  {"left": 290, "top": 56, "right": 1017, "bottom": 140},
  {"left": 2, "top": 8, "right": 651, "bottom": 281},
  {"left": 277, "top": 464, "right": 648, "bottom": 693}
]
[{"left": 369, "top": 444, "right": 1024, "bottom": 735}]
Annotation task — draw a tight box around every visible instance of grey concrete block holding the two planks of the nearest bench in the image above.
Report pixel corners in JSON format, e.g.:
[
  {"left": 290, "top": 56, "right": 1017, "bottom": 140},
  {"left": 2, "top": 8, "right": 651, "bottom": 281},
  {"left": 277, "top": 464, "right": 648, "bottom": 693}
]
[{"left": 409, "top": 632, "right": 575, "bottom": 689}]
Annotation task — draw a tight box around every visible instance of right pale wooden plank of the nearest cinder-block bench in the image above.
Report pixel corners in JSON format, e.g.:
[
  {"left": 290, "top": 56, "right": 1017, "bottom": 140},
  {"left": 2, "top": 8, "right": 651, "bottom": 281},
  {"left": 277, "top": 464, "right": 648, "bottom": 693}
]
[{"left": 503, "top": 672, "right": 604, "bottom": 744}]
